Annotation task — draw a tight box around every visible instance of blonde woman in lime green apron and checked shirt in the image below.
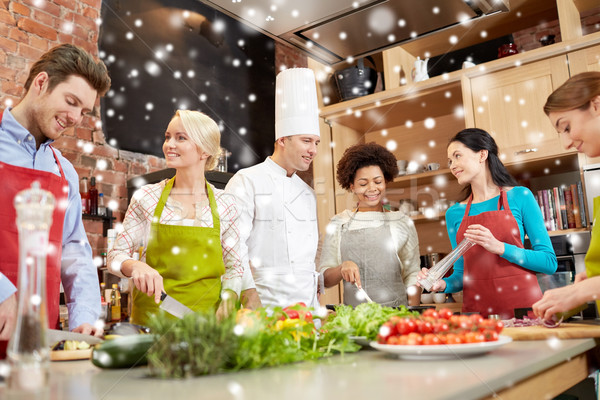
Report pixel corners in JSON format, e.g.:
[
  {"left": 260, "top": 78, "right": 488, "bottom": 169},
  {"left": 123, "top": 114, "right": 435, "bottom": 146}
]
[{"left": 108, "top": 110, "right": 243, "bottom": 325}]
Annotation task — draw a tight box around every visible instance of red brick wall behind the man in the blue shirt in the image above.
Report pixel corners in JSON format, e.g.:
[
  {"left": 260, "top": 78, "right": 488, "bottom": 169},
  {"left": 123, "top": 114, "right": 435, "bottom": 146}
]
[{"left": 0, "top": 0, "right": 165, "bottom": 255}]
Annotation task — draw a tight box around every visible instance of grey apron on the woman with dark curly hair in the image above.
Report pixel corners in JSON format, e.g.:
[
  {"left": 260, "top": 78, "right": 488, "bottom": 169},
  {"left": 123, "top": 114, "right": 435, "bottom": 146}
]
[{"left": 340, "top": 219, "right": 408, "bottom": 307}]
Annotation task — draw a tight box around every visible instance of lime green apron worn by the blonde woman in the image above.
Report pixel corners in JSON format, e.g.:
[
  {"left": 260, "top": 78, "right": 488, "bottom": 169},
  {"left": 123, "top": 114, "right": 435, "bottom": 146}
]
[{"left": 131, "top": 178, "right": 225, "bottom": 325}]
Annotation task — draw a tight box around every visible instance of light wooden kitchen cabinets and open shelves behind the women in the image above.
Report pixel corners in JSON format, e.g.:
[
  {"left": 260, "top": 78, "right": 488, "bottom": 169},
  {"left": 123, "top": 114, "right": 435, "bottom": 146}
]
[{"left": 308, "top": 6, "right": 600, "bottom": 302}]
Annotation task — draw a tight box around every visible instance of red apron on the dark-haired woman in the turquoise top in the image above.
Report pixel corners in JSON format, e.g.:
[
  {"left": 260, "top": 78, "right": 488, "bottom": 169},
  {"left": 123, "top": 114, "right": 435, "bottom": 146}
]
[{"left": 456, "top": 190, "right": 542, "bottom": 319}]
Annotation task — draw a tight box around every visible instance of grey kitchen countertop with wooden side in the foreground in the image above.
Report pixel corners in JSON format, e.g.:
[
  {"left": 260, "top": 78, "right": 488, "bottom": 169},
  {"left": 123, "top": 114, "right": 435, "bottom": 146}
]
[{"left": 0, "top": 339, "right": 596, "bottom": 400}]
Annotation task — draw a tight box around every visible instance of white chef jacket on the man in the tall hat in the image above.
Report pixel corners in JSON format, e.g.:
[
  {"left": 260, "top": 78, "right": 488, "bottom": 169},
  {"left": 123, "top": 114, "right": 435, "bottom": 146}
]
[{"left": 225, "top": 157, "right": 319, "bottom": 307}]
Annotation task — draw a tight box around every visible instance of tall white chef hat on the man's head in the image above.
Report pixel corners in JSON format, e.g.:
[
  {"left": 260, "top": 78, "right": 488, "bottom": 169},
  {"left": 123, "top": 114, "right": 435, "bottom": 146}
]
[{"left": 275, "top": 68, "right": 321, "bottom": 139}]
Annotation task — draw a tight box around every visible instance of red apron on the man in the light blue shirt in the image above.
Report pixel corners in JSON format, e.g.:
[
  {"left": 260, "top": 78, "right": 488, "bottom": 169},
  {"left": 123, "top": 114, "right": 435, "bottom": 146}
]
[{"left": 0, "top": 112, "right": 69, "bottom": 358}]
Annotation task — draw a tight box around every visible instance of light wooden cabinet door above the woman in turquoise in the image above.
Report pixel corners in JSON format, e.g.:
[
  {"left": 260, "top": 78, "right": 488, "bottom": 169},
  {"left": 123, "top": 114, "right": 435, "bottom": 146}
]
[{"left": 471, "top": 56, "right": 572, "bottom": 164}]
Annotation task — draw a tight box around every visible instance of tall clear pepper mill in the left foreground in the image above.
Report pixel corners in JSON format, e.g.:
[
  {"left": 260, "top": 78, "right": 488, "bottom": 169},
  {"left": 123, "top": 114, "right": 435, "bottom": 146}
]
[{"left": 7, "top": 181, "right": 54, "bottom": 391}]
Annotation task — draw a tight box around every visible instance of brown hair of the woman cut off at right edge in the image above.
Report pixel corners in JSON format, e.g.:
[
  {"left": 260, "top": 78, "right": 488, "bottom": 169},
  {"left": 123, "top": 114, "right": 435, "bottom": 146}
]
[{"left": 544, "top": 71, "right": 600, "bottom": 115}]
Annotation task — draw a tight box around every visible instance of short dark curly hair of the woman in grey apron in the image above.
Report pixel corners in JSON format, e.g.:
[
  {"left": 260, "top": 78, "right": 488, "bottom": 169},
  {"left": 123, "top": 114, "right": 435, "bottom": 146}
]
[{"left": 336, "top": 142, "right": 398, "bottom": 190}]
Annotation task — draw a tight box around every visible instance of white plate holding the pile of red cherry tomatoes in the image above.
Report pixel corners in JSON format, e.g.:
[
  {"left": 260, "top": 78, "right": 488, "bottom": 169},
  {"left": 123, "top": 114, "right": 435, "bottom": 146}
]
[{"left": 371, "top": 335, "right": 512, "bottom": 360}]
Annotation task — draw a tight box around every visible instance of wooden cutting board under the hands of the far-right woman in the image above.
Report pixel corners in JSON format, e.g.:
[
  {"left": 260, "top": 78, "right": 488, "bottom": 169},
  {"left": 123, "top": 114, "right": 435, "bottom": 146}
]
[{"left": 501, "top": 323, "right": 600, "bottom": 340}]
